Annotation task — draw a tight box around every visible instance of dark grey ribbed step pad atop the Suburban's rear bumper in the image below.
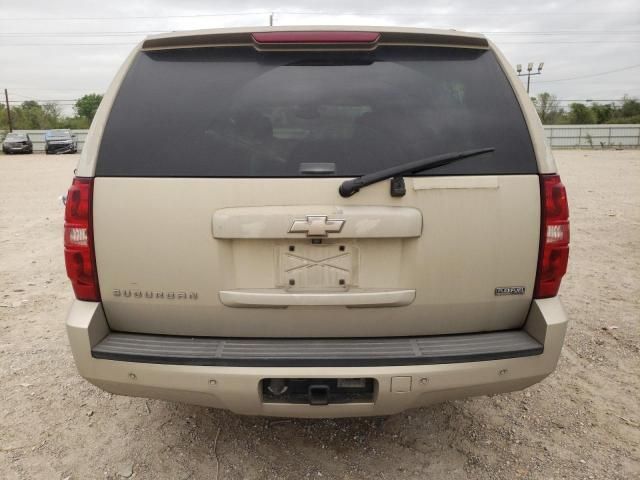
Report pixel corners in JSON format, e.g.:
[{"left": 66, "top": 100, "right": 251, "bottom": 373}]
[{"left": 91, "top": 330, "right": 544, "bottom": 367}]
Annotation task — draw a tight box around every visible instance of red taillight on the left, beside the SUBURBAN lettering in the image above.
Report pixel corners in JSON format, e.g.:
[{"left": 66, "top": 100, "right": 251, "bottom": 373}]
[{"left": 64, "top": 177, "right": 100, "bottom": 302}]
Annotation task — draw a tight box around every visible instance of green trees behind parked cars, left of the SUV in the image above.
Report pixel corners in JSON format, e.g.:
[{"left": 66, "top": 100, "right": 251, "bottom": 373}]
[{"left": 0, "top": 93, "right": 102, "bottom": 131}]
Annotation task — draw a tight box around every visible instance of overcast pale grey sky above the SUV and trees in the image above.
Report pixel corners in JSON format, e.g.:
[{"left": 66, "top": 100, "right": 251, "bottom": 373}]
[{"left": 0, "top": 0, "right": 640, "bottom": 114}]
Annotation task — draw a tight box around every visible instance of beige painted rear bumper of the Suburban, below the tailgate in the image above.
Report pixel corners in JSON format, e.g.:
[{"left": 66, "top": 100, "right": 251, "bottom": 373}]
[{"left": 67, "top": 298, "right": 567, "bottom": 417}]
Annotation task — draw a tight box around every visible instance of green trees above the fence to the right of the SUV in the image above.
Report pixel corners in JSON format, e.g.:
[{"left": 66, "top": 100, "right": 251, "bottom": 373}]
[{"left": 531, "top": 92, "right": 640, "bottom": 125}]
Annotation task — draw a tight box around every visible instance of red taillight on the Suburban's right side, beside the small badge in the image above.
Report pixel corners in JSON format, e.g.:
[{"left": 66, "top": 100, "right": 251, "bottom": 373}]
[{"left": 533, "top": 175, "right": 569, "bottom": 298}]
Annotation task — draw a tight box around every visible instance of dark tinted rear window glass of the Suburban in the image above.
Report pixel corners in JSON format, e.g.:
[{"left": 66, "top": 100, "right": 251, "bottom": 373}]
[{"left": 96, "top": 47, "right": 537, "bottom": 177}]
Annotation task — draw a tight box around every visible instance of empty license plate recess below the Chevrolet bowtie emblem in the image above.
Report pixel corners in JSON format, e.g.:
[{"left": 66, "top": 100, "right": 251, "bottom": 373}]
[{"left": 276, "top": 239, "right": 358, "bottom": 291}]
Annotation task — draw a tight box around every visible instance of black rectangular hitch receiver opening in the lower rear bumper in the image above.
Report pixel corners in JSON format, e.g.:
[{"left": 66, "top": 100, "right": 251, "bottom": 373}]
[{"left": 261, "top": 378, "right": 376, "bottom": 405}]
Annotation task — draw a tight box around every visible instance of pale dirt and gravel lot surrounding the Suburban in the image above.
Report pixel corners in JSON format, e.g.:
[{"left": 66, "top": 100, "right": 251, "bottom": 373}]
[{"left": 0, "top": 151, "right": 640, "bottom": 479}]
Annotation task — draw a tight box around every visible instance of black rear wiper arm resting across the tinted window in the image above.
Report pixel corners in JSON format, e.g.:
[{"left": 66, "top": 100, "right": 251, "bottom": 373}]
[{"left": 338, "top": 147, "right": 495, "bottom": 198}]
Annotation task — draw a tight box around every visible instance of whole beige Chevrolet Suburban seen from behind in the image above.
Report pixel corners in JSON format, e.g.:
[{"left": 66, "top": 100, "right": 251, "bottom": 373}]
[{"left": 65, "top": 27, "right": 569, "bottom": 417}]
